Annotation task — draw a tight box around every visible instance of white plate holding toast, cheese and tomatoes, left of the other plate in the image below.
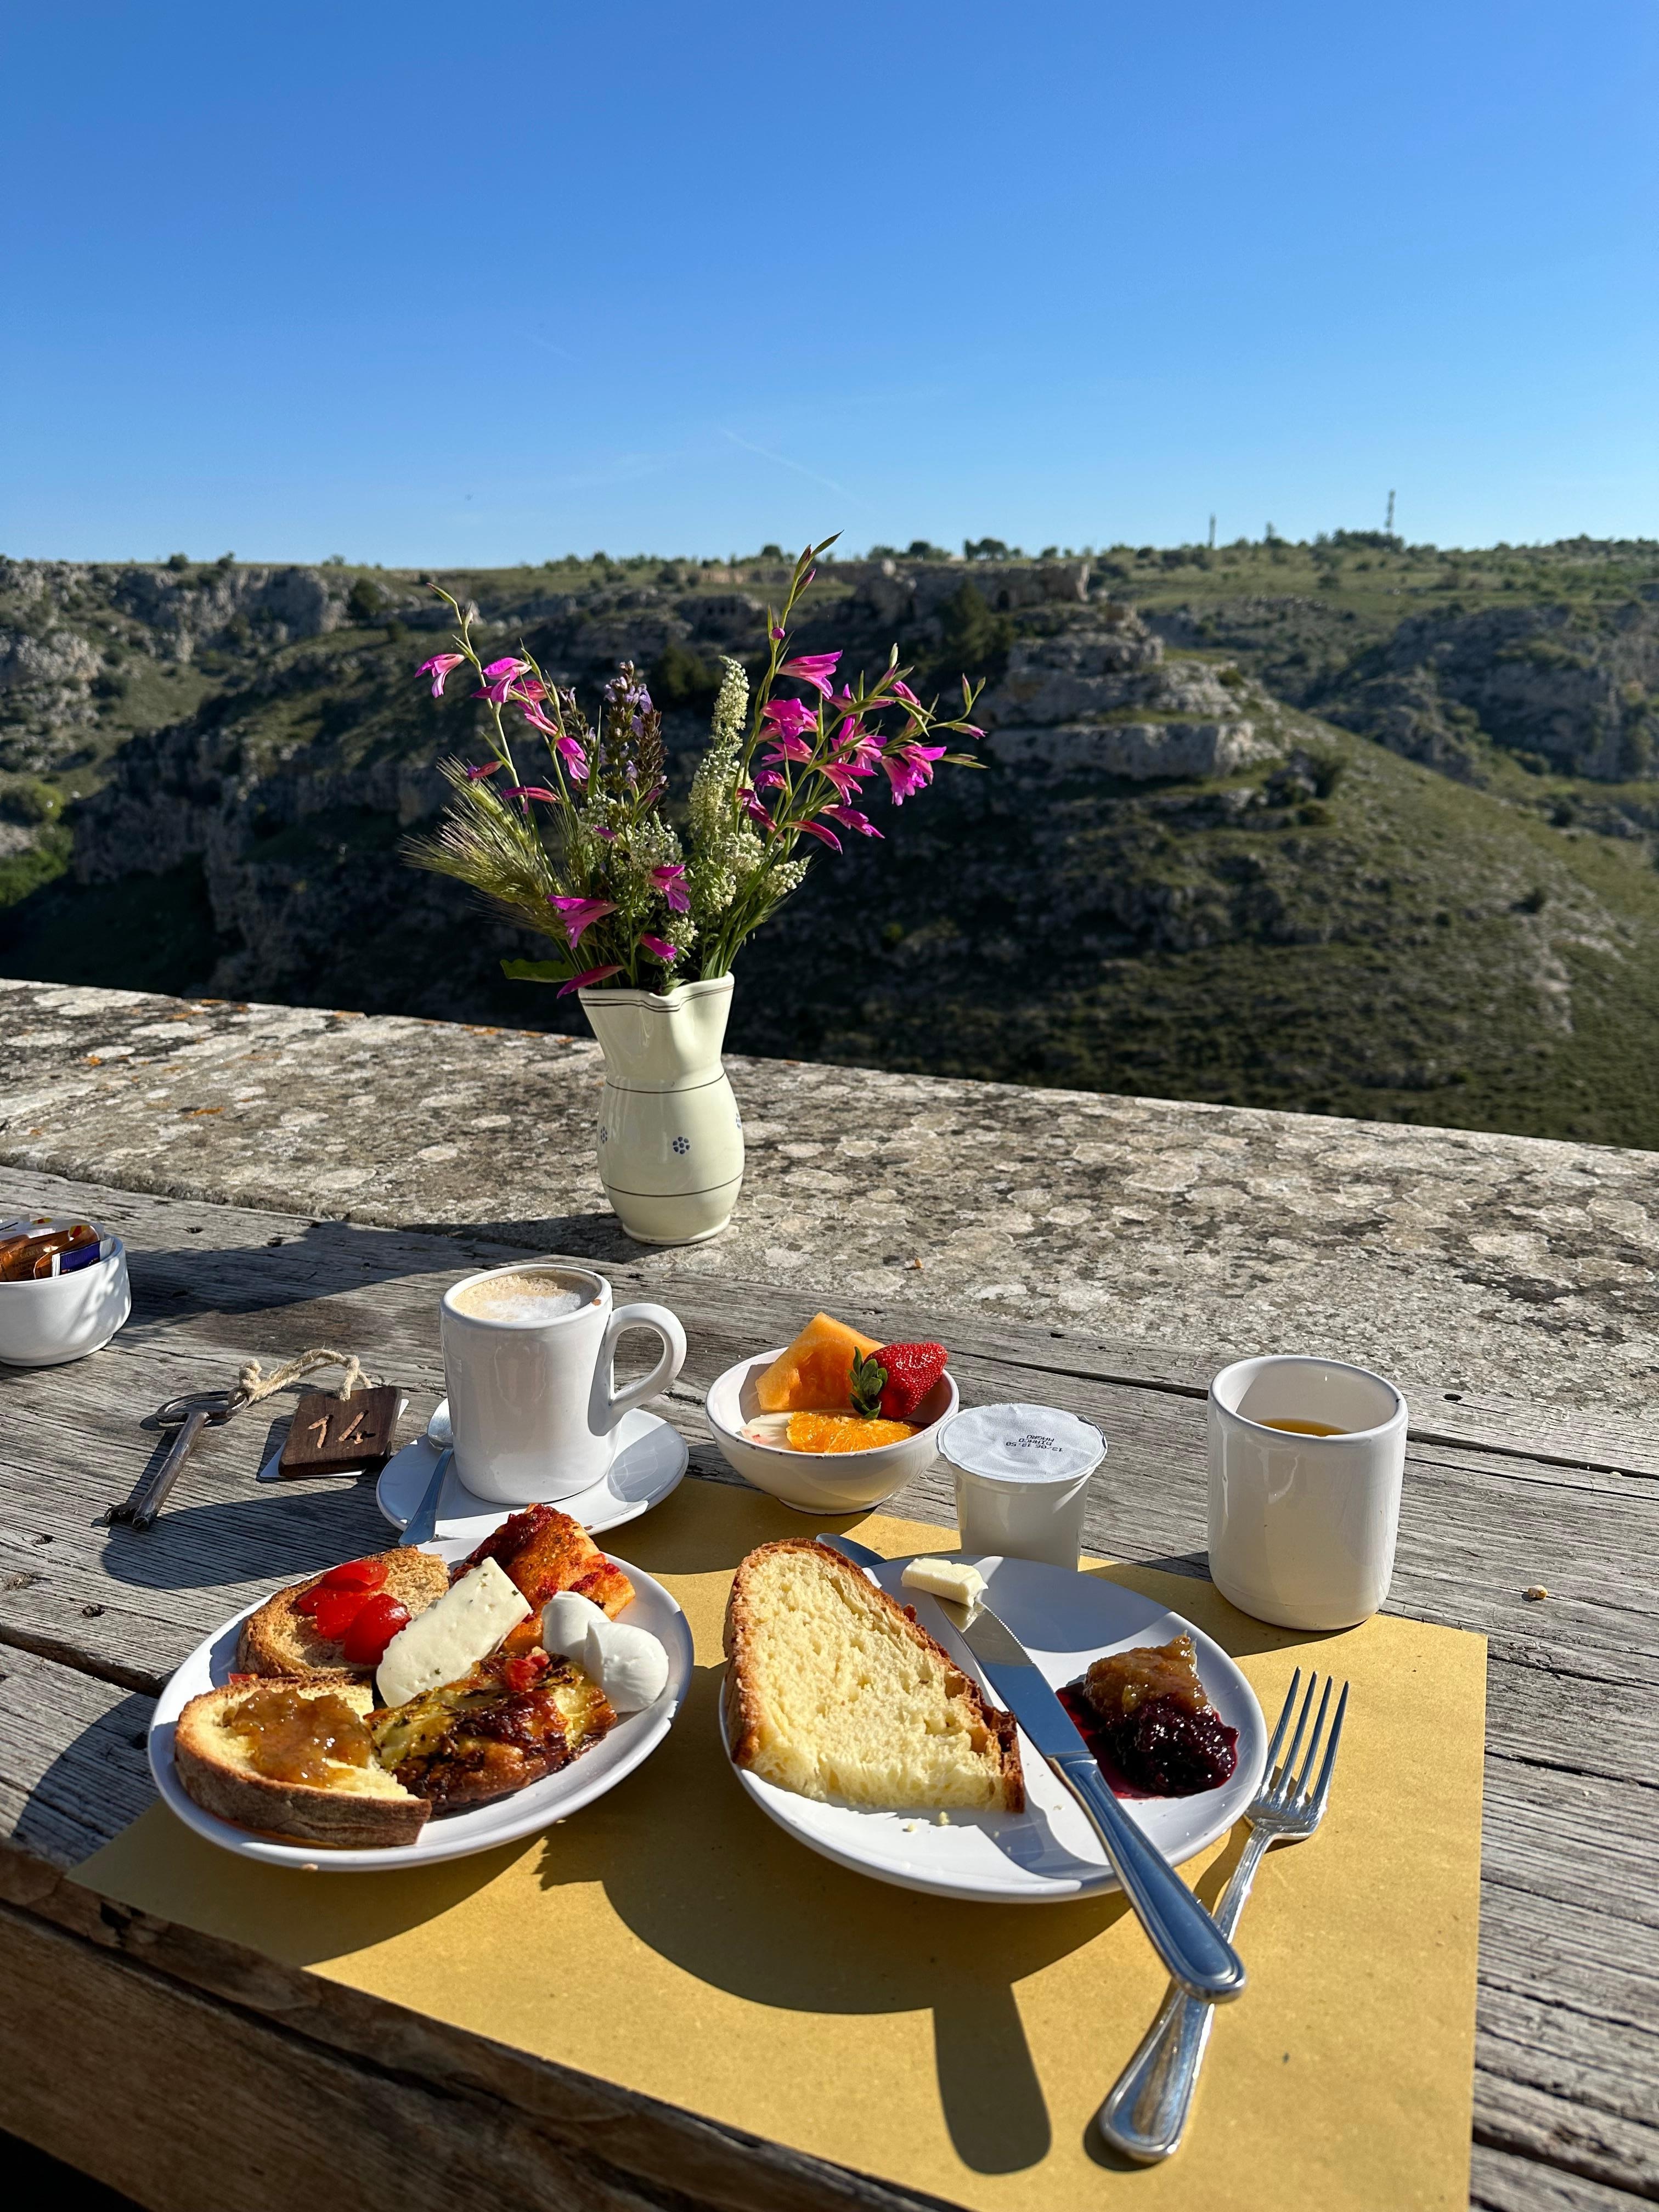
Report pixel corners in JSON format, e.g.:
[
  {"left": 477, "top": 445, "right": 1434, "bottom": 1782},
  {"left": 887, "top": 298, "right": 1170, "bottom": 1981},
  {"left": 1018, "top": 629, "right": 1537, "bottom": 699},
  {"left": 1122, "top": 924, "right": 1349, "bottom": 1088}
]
[{"left": 148, "top": 1537, "right": 692, "bottom": 1874}]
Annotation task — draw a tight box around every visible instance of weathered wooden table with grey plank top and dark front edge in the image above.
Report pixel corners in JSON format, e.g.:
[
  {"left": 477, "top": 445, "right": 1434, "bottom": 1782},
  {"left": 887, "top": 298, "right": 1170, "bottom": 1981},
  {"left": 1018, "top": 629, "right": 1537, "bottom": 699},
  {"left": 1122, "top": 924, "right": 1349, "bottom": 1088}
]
[{"left": 0, "top": 1170, "right": 1659, "bottom": 2212}]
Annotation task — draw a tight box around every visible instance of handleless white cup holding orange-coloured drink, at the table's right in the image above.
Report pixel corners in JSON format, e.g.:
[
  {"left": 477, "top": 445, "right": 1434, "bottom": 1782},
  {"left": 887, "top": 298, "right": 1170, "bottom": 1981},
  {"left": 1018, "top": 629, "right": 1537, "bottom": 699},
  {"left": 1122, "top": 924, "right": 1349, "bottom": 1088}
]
[{"left": 1210, "top": 1356, "right": 1407, "bottom": 1628}]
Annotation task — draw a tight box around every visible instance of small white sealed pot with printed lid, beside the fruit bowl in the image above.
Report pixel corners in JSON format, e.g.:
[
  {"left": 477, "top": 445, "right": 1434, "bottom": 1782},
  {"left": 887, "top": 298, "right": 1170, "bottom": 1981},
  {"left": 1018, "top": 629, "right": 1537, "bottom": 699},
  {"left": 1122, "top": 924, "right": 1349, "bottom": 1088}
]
[{"left": 938, "top": 1404, "right": 1106, "bottom": 1573}]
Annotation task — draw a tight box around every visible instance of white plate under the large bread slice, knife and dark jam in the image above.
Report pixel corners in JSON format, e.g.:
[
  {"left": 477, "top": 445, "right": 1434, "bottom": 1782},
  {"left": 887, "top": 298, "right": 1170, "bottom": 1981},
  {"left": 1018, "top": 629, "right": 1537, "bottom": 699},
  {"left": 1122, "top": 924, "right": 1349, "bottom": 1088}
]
[{"left": 721, "top": 1550, "right": 1267, "bottom": 1905}]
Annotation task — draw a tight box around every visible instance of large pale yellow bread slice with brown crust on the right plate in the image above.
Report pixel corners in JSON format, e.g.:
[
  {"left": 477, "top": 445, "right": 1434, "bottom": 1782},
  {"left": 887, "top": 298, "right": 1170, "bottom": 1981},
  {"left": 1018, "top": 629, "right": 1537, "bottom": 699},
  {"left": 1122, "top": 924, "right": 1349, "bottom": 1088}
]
[{"left": 723, "top": 1537, "right": 1026, "bottom": 1812}]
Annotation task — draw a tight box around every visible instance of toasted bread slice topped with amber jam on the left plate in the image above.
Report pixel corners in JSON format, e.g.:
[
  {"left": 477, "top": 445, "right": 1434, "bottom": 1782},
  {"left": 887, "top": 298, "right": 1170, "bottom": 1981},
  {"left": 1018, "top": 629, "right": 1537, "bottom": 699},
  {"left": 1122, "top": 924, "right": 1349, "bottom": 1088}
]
[{"left": 172, "top": 1677, "right": 431, "bottom": 1849}]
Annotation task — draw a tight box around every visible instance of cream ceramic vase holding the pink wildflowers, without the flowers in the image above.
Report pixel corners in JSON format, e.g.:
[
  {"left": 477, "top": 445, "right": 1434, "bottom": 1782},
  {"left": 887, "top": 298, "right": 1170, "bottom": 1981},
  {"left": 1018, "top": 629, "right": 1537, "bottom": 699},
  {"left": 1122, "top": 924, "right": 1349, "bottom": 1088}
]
[{"left": 582, "top": 975, "right": 743, "bottom": 1243}]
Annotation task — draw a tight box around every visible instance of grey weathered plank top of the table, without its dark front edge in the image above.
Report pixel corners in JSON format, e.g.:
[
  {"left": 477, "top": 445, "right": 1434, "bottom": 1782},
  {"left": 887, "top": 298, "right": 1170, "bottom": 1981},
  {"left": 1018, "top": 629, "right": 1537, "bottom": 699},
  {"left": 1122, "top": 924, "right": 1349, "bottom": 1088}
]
[{"left": 0, "top": 1181, "right": 1659, "bottom": 2205}]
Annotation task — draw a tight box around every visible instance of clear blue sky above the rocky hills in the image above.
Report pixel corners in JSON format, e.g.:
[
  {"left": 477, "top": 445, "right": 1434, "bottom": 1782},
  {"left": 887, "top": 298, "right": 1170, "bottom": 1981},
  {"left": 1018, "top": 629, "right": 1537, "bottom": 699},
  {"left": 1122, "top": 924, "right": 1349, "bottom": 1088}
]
[{"left": 0, "top": 0, "right": 1659, "bottom": 566}]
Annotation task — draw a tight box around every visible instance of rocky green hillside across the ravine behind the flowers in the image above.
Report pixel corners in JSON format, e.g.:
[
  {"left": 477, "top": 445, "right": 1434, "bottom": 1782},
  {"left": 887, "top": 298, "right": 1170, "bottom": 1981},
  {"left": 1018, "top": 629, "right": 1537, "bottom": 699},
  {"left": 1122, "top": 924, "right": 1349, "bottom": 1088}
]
[{"left": 0, "top": 544, "right": 1659, "bottom": 1142}]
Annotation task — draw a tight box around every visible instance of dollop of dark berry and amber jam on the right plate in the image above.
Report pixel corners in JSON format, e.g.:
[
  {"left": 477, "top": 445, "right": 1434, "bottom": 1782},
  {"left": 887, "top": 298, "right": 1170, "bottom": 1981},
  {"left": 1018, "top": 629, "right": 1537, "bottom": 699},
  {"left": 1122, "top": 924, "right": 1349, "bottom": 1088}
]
[{"left": 1062, "top": 1635, "right": 1239, "bottom": 1796}]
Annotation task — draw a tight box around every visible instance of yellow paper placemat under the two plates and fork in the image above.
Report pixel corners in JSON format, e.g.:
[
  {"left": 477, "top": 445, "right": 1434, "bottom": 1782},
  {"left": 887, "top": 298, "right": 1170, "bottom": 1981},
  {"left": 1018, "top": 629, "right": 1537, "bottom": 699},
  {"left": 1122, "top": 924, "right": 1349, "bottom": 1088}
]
[{"left": 77, "top": 1480, "right": 1487, "bottom": 2212}]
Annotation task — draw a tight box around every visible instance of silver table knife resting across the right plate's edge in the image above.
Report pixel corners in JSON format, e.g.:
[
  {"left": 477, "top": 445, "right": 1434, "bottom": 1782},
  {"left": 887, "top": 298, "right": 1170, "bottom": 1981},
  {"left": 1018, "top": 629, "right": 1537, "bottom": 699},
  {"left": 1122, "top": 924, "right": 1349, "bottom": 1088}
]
[{"left": 819, "top": 1535, "right": 1245, "bottom": 2004}]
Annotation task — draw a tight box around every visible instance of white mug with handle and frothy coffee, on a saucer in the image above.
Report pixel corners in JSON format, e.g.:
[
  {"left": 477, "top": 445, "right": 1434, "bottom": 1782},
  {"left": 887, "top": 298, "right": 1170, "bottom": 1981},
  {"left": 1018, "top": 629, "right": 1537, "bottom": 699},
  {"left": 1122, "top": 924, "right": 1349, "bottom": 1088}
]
[{"left": 442, "top": 1263, "right": 686, "bottom": 1506}]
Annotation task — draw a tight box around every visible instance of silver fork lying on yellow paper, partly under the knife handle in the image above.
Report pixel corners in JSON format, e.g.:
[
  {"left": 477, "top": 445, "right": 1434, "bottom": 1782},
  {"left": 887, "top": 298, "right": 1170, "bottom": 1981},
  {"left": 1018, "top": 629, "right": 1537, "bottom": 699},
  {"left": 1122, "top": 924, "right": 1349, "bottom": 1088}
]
[{"left": 1095, "top": 1668, "right": 1347, "bottom": 2165}]
